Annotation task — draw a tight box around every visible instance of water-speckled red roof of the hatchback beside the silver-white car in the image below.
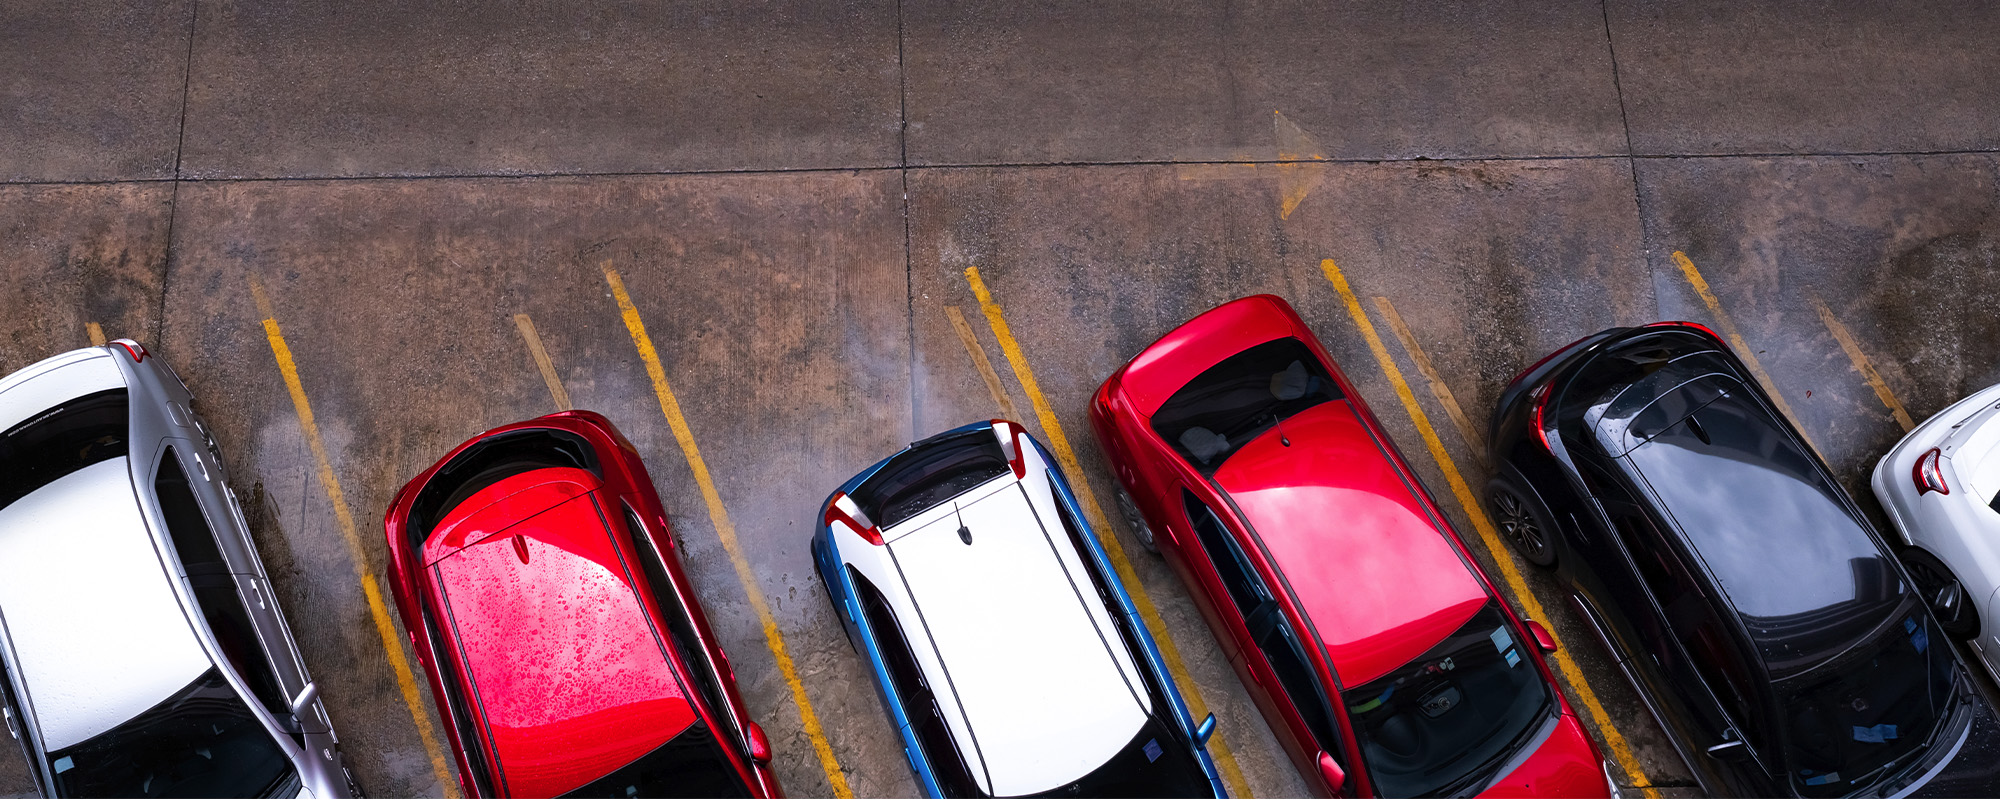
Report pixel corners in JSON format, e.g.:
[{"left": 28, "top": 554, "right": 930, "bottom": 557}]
[{"left": 424, "top": 468, "right": 696, "bottom": 796}]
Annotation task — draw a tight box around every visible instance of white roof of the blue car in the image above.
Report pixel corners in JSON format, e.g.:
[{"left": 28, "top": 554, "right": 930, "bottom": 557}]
[{"left": 884, "top": 470, "right": 1150, "bottom": 796}]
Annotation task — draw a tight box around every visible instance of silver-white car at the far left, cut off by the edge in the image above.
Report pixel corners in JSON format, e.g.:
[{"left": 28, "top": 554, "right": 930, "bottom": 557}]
[{"left": 0, "top": 340, "right": 358, "bottom": 798}]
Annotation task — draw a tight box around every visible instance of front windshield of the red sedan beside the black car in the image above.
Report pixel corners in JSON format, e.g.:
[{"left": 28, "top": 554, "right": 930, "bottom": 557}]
[{"left": 1342, "top": 600, "right": 1550, "bottom": 798}]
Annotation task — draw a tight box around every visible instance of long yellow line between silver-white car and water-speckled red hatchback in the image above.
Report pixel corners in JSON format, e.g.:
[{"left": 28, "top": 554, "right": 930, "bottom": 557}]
[{"left": 250, "top": 278, "right": 458, "bottom": 798}]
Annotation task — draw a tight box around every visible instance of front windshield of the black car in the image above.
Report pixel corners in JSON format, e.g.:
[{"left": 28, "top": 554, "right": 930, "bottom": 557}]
[{"left": 1774, "top": 600, "right": 1954, "bottom": 798}]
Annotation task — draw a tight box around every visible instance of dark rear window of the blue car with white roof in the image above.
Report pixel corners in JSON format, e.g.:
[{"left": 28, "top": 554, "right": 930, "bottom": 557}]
[{"left": 852, "top": 428, "right": 1010, "bottom": 528}]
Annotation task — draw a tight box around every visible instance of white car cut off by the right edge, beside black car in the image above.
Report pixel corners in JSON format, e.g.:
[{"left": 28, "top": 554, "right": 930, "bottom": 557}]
[{"left": 1870, "top": 378, "right": 2000, "bottom": 676}]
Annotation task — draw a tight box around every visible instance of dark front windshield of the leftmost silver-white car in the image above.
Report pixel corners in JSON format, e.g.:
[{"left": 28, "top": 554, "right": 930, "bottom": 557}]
[{"left": 48, "top": 668, "right": 298, "bottom": 798}]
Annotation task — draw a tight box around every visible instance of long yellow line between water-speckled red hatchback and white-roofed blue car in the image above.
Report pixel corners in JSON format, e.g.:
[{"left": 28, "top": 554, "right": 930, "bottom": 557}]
[{"left": 604, "top": 262, "right": 854, "bottom": 798}]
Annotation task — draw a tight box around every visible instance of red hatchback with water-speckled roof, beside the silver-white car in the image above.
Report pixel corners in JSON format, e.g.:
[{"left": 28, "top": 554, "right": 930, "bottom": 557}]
[{"left": 384, "top": 412, "right": 778, "bottom": 798}]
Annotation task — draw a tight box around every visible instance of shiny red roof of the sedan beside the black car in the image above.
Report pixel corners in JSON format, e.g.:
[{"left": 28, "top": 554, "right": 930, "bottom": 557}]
[{"left": 1216, "top": 400, "right": 1488, "bottom": 686}]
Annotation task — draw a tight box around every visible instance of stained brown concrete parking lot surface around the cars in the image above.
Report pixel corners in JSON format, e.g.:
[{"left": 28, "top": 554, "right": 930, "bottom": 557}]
[{"left": 0, "top": 0, "right": 2000, "bottom": 796}]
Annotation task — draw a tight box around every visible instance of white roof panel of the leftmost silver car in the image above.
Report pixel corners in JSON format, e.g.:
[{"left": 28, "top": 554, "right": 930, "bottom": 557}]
[{"left": 0, "top": 456, "right": 212, "bottom": 750}]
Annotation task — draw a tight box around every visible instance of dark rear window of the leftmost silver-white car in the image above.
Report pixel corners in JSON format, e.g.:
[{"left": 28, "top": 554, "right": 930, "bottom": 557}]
[{"left": 0, "top": 388, "right": 130, "bottom": 508}]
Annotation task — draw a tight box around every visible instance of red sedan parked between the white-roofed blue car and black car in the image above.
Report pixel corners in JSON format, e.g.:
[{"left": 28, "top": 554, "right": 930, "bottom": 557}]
[{"left": 1090, "top": 294, "right": 1614, "bottom": 796}]
